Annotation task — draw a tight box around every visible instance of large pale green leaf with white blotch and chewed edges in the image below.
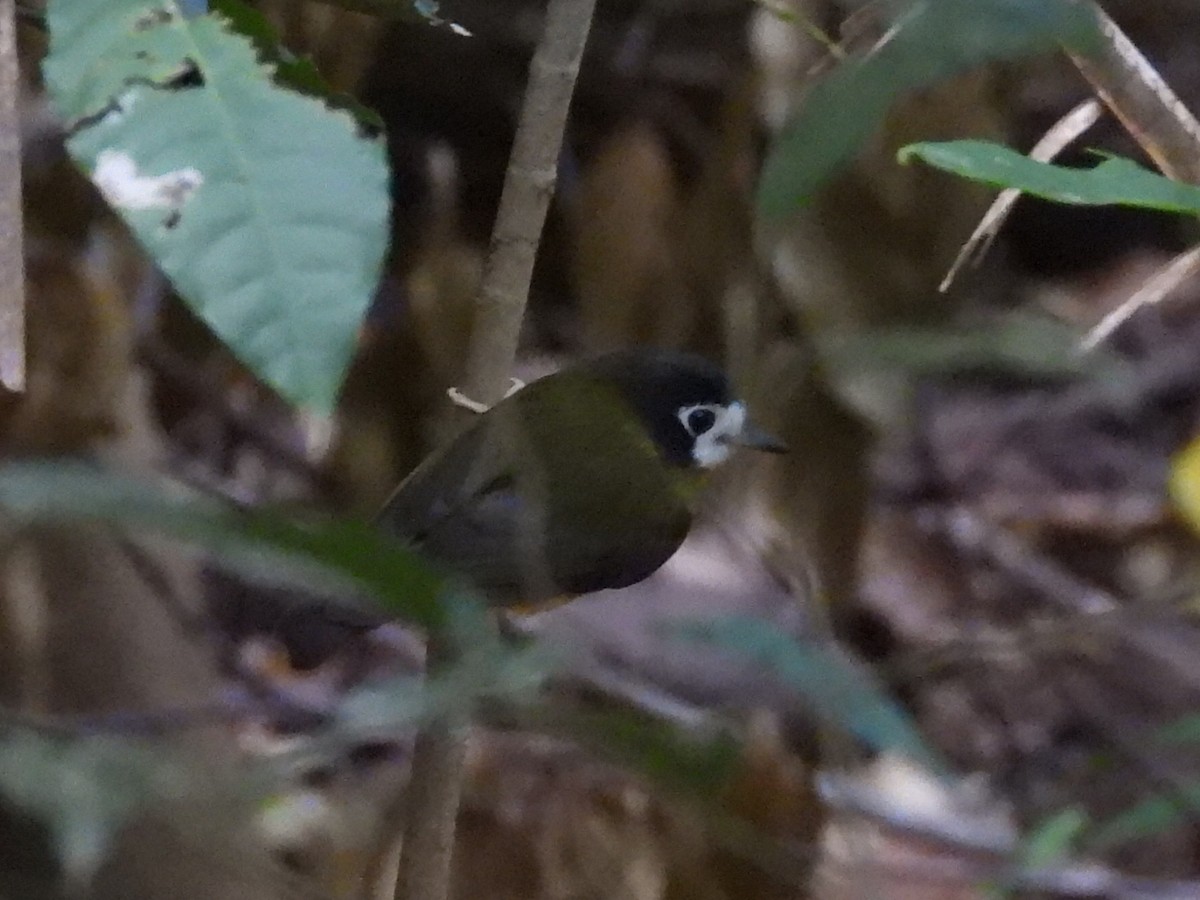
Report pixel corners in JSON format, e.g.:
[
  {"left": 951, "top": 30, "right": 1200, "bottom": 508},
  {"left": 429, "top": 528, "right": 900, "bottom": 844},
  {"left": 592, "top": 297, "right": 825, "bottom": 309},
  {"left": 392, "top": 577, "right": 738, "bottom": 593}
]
[{"left": 43, "top": 0, "right": 389, "bottom": 410}]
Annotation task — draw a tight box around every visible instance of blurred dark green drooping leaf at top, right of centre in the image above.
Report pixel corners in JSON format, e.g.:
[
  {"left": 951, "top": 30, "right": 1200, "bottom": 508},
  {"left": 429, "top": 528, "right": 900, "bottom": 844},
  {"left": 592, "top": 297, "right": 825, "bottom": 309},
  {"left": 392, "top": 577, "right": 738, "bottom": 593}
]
[{"left": 757, "top": 0, "right": 1100, "bottom": 216}]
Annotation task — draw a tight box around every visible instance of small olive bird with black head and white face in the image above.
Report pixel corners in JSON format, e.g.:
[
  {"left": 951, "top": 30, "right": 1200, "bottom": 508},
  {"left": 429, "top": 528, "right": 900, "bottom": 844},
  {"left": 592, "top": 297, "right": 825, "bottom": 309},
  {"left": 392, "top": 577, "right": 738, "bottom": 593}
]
[{"left": 379, "top": 349, "right": 785, "bottom": 611}]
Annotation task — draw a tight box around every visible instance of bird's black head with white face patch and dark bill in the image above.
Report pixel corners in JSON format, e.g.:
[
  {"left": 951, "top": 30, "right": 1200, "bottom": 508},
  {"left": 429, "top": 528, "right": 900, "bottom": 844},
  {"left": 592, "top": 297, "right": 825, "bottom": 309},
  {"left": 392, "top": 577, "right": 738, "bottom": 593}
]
[{"left": 584, "top": 349, "right": 784, "bottom": 469}]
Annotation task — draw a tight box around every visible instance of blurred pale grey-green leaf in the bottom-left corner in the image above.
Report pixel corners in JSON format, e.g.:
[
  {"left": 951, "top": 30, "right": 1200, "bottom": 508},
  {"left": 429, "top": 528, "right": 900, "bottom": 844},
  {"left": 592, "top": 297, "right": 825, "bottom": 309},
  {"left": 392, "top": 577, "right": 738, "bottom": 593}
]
[{"left": 0, "top": 727, "right": 186, "bottom": 888}]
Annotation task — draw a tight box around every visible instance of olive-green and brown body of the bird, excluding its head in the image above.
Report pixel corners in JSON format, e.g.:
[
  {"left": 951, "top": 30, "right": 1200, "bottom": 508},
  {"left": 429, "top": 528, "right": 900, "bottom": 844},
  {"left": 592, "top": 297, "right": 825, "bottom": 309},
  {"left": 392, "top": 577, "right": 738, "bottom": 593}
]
[{"left": 382, "top": 376, "right": 690, "bottom": 605}]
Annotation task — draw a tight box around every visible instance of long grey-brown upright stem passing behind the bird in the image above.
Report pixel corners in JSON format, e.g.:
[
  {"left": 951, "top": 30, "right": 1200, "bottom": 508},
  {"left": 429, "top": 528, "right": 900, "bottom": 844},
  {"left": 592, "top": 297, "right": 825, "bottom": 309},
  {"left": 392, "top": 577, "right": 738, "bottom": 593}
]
[{"left": 395, "top": 0, "right": 595, "bottom": 900}]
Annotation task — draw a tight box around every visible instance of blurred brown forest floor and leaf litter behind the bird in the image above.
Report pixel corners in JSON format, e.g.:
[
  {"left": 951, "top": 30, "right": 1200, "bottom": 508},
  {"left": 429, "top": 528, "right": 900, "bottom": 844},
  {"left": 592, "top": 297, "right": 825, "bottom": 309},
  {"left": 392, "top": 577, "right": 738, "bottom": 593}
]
[{"left": 7, "top": 0, "right": 1200, "bottom": 900}]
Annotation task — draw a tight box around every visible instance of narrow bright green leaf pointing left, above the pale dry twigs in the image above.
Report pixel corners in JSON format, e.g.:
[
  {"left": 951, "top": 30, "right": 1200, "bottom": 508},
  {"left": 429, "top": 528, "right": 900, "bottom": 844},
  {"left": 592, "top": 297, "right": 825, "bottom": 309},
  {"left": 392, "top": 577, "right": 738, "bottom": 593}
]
[{"left": 899, "top": 140, "right": 1200, "bottom": 216}]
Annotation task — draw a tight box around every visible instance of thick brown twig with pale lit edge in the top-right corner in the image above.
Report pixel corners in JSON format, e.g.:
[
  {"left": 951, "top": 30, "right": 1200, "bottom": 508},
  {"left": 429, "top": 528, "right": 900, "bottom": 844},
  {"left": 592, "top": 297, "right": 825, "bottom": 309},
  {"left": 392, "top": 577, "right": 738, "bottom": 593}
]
[{"left": 1068, "top": 2, "right": 1200, "bottom": 184}]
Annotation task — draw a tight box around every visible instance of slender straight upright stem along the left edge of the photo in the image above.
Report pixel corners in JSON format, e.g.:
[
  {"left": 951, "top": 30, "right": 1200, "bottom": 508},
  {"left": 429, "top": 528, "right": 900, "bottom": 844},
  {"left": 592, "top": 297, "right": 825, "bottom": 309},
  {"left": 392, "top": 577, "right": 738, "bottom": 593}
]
[{"left": 0, "top": 0, "right": 25, "bottom": 391}]
